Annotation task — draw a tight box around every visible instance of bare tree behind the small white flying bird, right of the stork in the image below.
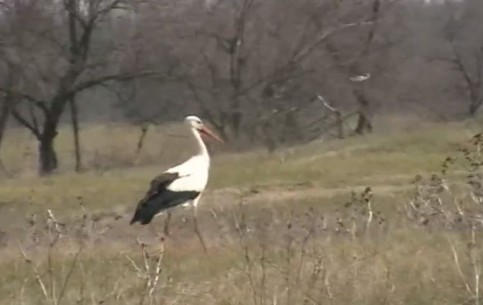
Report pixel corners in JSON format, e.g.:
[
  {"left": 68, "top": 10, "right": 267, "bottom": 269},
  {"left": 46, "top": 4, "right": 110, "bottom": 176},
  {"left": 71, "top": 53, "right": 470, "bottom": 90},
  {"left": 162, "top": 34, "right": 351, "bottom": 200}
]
[{"left": 325, "top": 0, "right": 410, "bottom": 135}]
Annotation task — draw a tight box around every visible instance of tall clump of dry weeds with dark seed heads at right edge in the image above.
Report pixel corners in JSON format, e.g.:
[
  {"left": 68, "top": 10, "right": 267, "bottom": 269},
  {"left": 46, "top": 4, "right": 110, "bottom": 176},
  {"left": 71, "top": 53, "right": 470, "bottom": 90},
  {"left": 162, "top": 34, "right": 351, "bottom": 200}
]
[{"left": 406, "top": 133, "right": 483, "bottom": 305}]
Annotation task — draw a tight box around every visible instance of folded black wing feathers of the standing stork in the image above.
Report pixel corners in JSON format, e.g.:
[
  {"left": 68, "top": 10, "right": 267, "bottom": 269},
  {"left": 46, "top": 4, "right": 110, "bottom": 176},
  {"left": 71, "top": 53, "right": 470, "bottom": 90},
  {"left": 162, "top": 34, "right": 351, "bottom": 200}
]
[{"left": 131, "top": 173, "right": 199, "bottom": 225}]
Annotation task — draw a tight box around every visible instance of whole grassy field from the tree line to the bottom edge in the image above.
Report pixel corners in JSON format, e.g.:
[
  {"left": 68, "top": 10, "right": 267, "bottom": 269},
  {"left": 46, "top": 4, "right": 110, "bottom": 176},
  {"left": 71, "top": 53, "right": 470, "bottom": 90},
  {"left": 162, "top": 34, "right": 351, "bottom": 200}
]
[{"left": 0, "top": 117, "right": 483, "bottom": 305}]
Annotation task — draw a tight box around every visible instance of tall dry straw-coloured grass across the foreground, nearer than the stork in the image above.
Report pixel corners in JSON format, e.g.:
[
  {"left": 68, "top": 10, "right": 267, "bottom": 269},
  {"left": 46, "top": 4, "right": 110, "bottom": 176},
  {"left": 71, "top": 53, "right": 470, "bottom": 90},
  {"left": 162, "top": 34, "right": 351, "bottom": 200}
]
[{"left": 0, "top": 188, "right": 482, "bottom": 304}]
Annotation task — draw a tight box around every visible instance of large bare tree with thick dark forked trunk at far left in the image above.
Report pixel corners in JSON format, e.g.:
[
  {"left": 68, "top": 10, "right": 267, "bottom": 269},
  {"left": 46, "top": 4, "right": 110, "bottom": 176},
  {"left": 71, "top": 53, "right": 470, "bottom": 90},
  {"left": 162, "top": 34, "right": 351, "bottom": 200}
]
[{"left": 0, "top": 0, "right": 160, "bottom": 174}]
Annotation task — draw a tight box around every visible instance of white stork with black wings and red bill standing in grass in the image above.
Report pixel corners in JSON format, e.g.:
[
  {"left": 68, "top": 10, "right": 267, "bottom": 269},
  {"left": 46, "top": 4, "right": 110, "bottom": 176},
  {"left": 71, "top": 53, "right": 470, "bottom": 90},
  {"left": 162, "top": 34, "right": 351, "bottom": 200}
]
[{"left": 131, "top": 116, "right": 223, "bottom": 227}]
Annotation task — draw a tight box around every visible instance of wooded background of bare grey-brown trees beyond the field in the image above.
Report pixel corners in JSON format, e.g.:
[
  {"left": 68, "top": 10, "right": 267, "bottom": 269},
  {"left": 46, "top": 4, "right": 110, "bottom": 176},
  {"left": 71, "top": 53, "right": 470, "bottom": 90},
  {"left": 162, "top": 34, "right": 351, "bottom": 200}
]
[{"left": 0, "top": 0, "right": 483, "bottom": 174}]
